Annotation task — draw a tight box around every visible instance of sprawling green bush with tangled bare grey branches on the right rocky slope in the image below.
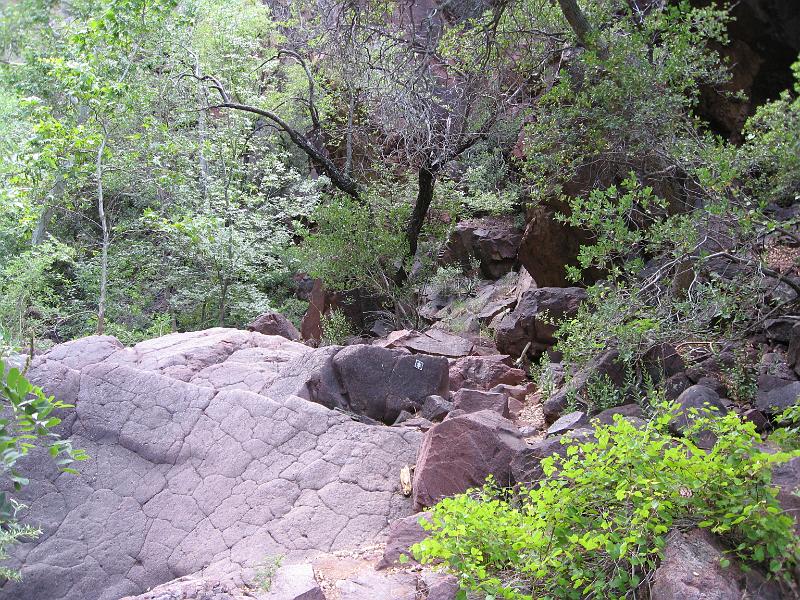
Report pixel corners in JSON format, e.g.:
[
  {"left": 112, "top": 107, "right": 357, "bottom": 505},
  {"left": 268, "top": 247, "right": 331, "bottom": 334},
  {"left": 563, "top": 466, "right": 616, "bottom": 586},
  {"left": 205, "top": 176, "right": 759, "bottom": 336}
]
[{"left": 556, "top": 174, "right": 780, "bottom": 366}]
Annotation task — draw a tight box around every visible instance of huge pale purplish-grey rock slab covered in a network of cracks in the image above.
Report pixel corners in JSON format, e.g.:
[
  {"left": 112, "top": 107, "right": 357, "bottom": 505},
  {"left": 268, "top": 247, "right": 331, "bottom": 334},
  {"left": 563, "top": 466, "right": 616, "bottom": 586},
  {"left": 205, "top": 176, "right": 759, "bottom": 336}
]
[{"left": 0, "top": 328, "right": 424, "bottom": 600}]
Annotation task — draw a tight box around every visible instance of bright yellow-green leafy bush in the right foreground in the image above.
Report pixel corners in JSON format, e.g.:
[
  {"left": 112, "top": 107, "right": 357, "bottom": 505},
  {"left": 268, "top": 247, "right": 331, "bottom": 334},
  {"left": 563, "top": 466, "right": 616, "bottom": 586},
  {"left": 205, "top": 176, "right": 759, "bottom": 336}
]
[{"left": 413, "top": 405, "right": 800, "bottom": 600}]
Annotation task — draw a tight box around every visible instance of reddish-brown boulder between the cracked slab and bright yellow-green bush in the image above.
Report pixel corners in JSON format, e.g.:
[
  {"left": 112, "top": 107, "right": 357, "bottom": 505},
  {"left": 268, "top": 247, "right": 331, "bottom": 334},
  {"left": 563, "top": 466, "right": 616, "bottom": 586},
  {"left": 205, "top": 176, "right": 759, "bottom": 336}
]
[{"left": 413, "top": 410, "right": 525, "bottom": 510}]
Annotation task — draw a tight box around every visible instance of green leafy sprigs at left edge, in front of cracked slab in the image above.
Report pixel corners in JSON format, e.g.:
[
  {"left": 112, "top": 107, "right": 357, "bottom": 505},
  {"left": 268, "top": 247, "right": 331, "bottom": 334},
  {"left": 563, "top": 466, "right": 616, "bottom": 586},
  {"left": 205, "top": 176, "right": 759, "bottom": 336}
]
[{"left": 0, "top": 360, "right": 87, "bottom": 579}]
